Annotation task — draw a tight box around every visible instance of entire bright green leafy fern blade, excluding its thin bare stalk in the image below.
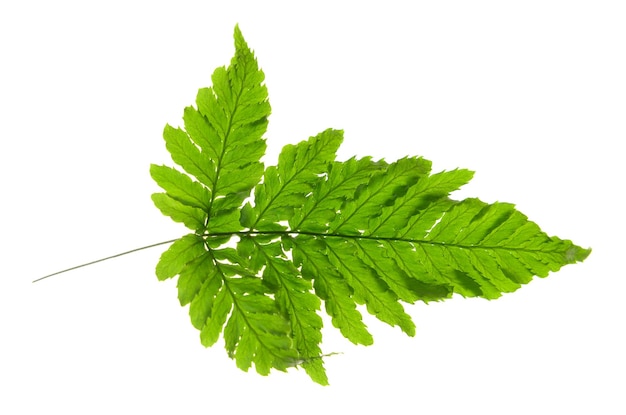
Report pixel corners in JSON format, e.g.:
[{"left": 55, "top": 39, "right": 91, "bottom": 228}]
[{"left": 151, "top": 24, "right": 590, "bottom": 384}]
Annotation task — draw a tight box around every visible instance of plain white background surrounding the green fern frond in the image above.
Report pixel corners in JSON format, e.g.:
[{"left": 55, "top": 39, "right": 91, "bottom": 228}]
[{"left": 0, "top": 0, "right": 626, "bottom": 414}]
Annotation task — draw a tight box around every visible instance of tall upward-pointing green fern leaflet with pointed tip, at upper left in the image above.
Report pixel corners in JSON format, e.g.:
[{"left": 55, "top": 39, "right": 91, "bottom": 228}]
[{"left": 152, "top": 24, "right": 271, "bottom": 236}]
